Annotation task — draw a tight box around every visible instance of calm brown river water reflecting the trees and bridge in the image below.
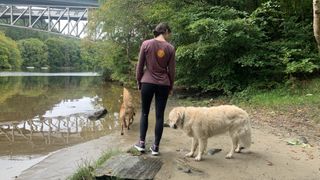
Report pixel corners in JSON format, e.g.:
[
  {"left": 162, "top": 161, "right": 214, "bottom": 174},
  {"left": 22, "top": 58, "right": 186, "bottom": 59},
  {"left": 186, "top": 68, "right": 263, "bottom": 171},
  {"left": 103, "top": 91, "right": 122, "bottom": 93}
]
[{"left": 0, "top": 72, "right": 138, "bottom": 177}]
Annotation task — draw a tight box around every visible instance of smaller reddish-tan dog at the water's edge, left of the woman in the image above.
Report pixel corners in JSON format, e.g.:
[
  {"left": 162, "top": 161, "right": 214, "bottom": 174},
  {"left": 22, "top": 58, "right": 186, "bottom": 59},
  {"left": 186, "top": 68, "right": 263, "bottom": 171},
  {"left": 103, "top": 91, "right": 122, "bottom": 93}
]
[{"left": 119, "top": 88, "right": 135, "bottom": 135}]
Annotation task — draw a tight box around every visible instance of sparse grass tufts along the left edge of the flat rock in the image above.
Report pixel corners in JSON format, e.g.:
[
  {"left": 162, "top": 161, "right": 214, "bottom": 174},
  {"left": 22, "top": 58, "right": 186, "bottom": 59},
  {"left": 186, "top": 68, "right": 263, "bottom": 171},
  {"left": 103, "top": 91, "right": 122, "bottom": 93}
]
[{"left": 68, "top": 150, "right": 121, "bottom": 180}]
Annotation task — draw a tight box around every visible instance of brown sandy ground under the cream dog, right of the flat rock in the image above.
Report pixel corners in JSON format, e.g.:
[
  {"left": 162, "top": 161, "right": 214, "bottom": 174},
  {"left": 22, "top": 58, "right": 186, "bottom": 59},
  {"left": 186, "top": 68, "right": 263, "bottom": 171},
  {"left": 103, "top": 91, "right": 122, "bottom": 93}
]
[{"left": 124, "top": 105, "right": 320, "bottom": 180}]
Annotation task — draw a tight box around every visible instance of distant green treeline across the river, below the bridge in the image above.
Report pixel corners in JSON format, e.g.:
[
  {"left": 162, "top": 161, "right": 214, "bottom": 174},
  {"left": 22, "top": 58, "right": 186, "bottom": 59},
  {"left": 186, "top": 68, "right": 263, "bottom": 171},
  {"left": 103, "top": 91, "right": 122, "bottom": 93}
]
[{"left": 0, "top": 28, "right": 99, "bottom": 71}]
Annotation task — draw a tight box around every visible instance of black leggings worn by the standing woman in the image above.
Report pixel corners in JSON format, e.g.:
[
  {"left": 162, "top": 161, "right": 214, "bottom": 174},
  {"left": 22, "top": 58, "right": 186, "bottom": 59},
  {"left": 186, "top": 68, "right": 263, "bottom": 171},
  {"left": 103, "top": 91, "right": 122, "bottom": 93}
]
[{"left": 140, "top": 83, "right": 169, "bottom": 146}]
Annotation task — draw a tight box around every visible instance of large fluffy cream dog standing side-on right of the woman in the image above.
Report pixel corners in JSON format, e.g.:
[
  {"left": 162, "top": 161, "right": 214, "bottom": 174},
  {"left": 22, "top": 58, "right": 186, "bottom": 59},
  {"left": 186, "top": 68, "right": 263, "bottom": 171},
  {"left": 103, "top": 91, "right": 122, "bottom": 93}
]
[{"left": 169, "top": 105, "right": 251, "bottom": 161}]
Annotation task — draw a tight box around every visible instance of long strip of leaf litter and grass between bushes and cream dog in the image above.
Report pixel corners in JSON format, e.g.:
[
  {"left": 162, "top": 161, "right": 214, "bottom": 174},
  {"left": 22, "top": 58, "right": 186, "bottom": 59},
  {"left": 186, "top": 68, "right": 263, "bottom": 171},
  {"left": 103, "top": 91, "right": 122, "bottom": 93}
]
[{"left": 176, "top": 78, "right": 320, "bottom": 123}]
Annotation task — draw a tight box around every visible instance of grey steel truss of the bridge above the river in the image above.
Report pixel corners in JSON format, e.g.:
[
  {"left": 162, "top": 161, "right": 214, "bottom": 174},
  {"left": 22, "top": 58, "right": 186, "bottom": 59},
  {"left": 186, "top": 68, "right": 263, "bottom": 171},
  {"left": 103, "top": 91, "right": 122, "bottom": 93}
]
[{"left": 0, "top": 4, "right": 95, "bottom": 37}]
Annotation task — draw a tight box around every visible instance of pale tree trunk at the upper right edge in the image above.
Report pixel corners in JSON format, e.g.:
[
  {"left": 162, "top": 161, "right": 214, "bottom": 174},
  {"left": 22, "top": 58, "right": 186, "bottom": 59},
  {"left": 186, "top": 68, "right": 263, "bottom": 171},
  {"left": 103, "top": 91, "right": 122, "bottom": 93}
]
[{"left": 313, "top": 0, "right": 320, "bottom": 53}]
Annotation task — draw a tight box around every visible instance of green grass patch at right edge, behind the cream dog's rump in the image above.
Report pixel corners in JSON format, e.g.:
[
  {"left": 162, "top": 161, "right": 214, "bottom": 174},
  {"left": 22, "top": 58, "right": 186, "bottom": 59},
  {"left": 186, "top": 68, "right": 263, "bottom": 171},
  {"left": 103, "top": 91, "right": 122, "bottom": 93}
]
[{"left": 231, "top": 78, "right": 320, "bottom": 123}]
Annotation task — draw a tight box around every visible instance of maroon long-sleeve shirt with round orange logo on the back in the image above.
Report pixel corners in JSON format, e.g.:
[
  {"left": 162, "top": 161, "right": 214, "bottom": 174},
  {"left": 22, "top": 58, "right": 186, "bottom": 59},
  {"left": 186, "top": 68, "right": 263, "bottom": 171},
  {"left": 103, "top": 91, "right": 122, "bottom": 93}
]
[{"left": 136, "top": 39, "right": 176, "bottom": 90}]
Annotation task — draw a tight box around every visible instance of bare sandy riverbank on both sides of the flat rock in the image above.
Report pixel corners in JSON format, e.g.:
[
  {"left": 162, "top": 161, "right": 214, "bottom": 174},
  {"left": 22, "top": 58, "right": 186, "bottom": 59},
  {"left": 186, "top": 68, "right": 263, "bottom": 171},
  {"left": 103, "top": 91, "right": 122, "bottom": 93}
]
[{"left": 19, "top": 102, "right": 320, "bottom": 180}]
